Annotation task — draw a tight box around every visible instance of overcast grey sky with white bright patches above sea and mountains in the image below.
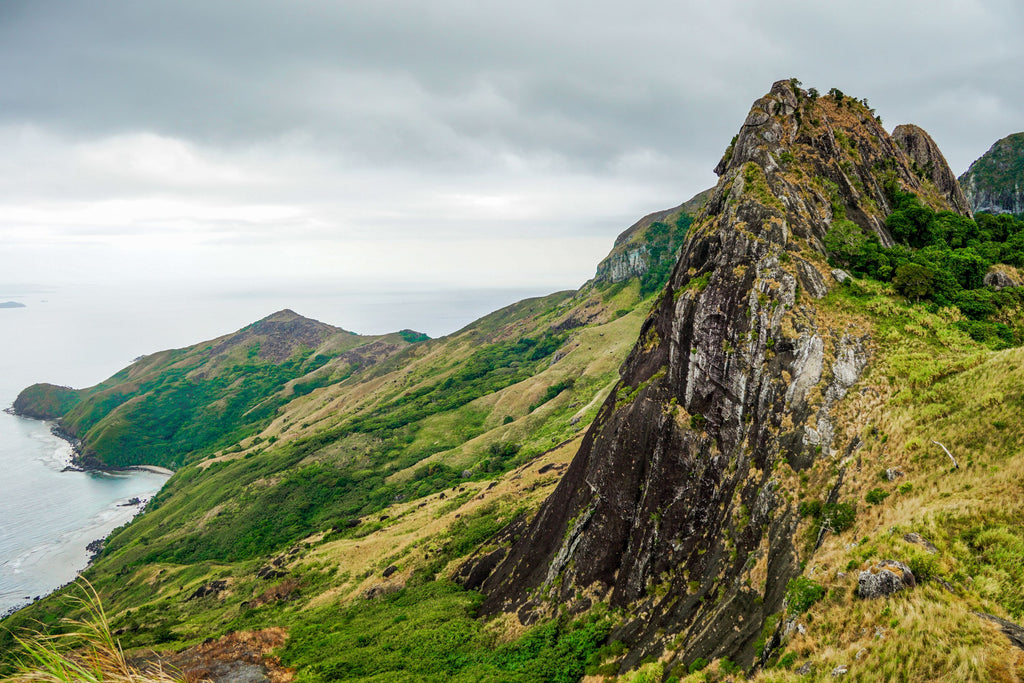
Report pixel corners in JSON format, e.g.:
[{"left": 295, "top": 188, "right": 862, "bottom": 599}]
[{"left": 0, "top": 0, "right": 1024, "bottom": 291}]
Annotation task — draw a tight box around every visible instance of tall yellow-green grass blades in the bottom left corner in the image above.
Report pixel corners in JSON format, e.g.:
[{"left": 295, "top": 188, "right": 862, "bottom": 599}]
[{"left": 3, "top": 580, "right": 184, "bottom": 683}]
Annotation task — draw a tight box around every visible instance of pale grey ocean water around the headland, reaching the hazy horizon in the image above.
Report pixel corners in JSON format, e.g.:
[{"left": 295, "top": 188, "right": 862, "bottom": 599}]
[{"left": 0, "top": 283, "right": 547, "bottom": 614}]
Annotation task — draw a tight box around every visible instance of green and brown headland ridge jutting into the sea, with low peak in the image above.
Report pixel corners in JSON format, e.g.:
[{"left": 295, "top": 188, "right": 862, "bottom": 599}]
[{"left": 13, "top": 309, "right": 417, "bottom": 468}]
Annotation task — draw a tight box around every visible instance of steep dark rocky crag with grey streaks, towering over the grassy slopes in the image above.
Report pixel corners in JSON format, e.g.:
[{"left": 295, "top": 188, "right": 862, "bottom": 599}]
[{"left": 465, "top": 81, "right": 962, "bottom": 669}]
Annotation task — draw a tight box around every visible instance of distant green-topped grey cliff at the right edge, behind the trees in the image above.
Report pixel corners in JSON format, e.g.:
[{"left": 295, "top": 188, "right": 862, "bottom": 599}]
[{"left": 959, "top": 133, "right": 1024, "bottom": 214}]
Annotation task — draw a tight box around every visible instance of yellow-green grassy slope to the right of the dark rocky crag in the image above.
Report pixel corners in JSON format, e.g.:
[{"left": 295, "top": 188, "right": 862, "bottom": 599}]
[{"left": 741, "top": 281, "right": 1024, "bottom": 681}]
